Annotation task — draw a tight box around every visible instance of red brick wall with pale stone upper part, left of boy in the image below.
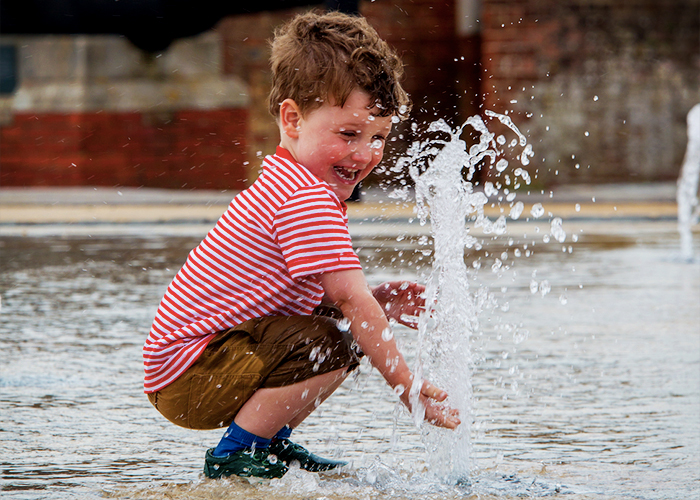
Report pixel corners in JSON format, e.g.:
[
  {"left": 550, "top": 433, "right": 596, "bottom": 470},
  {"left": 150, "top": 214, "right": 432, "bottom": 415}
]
[{"left": 0, "top": 32, "right": 250, "bottom": 189}]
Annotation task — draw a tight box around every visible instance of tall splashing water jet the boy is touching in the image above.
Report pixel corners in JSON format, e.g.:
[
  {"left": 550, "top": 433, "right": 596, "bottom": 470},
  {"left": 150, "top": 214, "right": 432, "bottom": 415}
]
[{"left": 400, "top": 111, "right": 532, "bottom": 483}]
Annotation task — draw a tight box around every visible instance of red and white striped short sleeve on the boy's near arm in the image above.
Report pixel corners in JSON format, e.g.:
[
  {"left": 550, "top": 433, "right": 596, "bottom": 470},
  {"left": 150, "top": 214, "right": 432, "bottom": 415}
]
[{"left": 273, "top": 185, "right": 362, "bottom": 279}]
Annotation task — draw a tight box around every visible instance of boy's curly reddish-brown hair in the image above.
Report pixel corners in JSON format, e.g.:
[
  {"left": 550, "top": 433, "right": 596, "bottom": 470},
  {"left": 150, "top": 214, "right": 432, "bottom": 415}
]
[{"left": 269, "top": 12, "right": 411, "bottom": 119}]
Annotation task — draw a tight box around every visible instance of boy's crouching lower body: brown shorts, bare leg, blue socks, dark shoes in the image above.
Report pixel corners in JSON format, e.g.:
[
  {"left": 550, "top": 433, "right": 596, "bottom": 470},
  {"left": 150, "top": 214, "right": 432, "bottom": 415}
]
[{"left": 149, "top": 316, "right": 361, "bottom": 478}]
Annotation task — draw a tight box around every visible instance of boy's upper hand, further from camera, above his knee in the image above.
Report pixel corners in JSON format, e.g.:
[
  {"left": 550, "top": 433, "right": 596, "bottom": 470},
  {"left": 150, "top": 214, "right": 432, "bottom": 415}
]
[{"left": 372, "top": 281, "right": 425, "bottom": 329}]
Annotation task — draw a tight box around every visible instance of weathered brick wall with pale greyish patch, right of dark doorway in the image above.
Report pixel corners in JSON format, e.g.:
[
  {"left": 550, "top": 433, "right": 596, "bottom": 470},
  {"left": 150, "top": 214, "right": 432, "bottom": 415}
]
[{"left": 482, "top": 0, "right": 700, "bottom": 184}]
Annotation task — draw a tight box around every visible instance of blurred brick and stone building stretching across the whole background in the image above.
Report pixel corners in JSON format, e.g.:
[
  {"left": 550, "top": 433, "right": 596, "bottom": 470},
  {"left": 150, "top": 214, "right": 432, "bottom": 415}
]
[{"left": 0, "top": 0, "right": 700, "bottom": 189}]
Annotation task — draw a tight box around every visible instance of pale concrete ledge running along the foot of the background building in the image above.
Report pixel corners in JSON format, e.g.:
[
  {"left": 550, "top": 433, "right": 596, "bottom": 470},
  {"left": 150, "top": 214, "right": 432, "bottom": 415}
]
[{"left": 0, "top": 184, "right": 677, "bottom": 225}]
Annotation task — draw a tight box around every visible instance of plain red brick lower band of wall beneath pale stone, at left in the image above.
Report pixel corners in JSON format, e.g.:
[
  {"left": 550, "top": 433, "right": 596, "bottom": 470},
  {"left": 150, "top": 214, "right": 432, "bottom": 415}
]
[{"left": 0, "top": 109, "right": 248, "bottom": 189}]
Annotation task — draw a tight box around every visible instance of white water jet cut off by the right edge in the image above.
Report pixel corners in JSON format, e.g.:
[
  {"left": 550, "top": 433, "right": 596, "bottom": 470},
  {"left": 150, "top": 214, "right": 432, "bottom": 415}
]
[{"left": 676, "top": 104, "right": 700, "bottom": 261}]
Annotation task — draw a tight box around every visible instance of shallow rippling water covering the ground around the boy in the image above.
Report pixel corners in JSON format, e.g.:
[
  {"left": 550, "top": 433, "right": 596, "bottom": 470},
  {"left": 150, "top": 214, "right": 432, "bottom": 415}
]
[{"left": 0, "top": 225, "right": 700, "bottom": 500}]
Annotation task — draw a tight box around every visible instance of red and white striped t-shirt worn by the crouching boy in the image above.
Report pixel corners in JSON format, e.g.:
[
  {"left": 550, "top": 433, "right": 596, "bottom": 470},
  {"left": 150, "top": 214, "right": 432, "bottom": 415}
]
[{"left": 143, "top": 148, "right": 361, "bottom": 393}]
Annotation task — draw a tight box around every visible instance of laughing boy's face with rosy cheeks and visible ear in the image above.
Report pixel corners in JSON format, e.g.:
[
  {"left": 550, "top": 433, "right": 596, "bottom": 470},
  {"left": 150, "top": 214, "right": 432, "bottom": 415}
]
[{"left": 280, "top": 90, "right": 392, "bottom": 200}]
